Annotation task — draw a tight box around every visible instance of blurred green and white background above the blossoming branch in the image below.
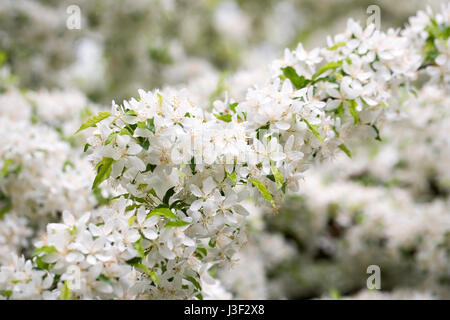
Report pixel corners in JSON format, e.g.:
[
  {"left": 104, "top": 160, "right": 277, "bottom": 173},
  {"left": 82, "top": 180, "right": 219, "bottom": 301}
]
[{"left": 0, "top": 0, "right": 439, "bottom": 103}]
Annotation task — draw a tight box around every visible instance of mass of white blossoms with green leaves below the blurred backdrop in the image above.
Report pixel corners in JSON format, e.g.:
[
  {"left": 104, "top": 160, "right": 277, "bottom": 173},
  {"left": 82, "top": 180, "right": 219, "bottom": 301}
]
[{"left": 0, "top": 2, "right": 450, "bottom": 299}]
